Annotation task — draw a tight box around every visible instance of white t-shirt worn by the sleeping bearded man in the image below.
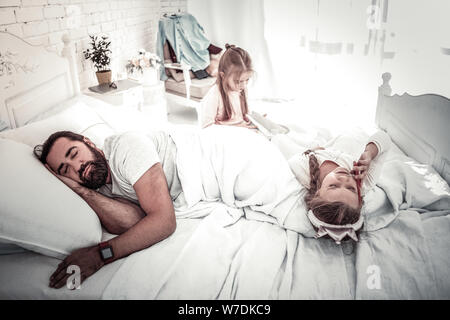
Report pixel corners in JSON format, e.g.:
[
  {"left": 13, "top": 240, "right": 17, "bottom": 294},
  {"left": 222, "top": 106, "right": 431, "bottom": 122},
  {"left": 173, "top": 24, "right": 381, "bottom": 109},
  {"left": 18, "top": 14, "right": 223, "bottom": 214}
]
[{"left": 98, "top": 131, "right": 184, "bottom": 205}]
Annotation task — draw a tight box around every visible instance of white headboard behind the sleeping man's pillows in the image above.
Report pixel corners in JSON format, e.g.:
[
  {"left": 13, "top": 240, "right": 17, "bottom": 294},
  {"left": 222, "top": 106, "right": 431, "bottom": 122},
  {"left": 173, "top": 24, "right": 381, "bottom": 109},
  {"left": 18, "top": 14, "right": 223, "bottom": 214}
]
[{"left": 0, "top": 32, "right": 80, "bottom": 128}]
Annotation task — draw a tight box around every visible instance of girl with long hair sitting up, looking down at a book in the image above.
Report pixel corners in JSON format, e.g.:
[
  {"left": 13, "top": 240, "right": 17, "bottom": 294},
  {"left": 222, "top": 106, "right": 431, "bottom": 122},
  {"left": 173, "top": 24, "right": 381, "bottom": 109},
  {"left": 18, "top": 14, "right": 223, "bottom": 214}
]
[{"left": 200, "top": 44, "right": 256, "bottom": 129}]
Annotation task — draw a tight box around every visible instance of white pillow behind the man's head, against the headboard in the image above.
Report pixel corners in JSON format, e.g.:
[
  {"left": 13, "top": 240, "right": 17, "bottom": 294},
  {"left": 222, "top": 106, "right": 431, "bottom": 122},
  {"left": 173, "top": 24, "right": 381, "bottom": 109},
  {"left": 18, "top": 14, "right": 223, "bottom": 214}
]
[{"left": 0, "top": 100, "right": 116, "bottom": 148}]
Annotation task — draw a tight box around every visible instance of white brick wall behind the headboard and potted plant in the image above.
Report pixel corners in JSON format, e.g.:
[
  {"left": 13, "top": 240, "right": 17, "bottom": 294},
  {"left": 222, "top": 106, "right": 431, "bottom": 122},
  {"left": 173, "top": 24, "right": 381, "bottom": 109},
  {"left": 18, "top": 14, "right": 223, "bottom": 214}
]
[{"left": 0, "top": 0, "right": 187, "bottom": 89}]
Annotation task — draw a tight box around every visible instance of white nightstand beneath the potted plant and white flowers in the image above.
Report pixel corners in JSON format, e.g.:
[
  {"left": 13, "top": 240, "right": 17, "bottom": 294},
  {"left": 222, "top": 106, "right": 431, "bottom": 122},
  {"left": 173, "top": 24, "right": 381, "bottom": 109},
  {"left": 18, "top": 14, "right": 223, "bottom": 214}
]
[{"left": 83, "top": 79, "right": 144, "bottom": 110}]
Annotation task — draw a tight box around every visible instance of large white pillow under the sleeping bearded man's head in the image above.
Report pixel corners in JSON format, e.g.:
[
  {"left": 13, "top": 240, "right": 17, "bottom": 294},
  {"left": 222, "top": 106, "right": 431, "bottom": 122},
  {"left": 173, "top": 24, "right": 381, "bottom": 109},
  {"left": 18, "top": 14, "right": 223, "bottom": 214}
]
[{"left": 0, "top": 138, "right": 102, "bottom": 258}]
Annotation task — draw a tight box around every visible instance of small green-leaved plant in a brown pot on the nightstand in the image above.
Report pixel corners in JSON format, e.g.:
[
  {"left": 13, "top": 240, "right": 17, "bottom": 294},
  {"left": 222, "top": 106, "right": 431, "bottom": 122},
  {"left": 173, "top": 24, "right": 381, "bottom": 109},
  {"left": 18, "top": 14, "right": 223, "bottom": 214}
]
[{"left": 83, "top": 35, "right": 111, "bottom": 84}]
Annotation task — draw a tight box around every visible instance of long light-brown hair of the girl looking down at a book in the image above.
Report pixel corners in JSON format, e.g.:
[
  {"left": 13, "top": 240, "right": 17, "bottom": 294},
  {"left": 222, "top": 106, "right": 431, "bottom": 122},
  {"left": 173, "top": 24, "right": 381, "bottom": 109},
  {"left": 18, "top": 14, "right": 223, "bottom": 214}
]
[{"left": 216, "top": 43, "right": 254, "bottom": 121}]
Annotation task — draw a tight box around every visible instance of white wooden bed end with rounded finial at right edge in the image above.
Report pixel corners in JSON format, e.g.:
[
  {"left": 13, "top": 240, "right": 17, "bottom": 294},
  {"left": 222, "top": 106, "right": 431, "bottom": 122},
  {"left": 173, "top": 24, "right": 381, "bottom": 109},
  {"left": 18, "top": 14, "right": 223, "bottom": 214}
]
[{"left": 376, "top": 73, "right": 450, "bottom": 184}]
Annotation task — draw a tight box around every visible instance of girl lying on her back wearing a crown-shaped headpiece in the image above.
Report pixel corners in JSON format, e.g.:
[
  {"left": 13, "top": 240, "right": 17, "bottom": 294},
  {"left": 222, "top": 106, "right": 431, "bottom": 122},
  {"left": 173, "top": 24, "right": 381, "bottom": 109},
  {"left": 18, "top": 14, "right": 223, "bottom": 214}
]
[{"left": 289, "top": 131, "right": 391, "bottom": 244}]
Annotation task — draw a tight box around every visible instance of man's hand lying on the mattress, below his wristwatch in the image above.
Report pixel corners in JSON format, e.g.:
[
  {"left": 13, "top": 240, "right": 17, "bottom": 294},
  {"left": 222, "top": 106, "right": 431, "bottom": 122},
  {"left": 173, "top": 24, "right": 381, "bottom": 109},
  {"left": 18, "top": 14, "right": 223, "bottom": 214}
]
[{"left": 49, "top": 246, "right": 104, "bottom": 289}]
